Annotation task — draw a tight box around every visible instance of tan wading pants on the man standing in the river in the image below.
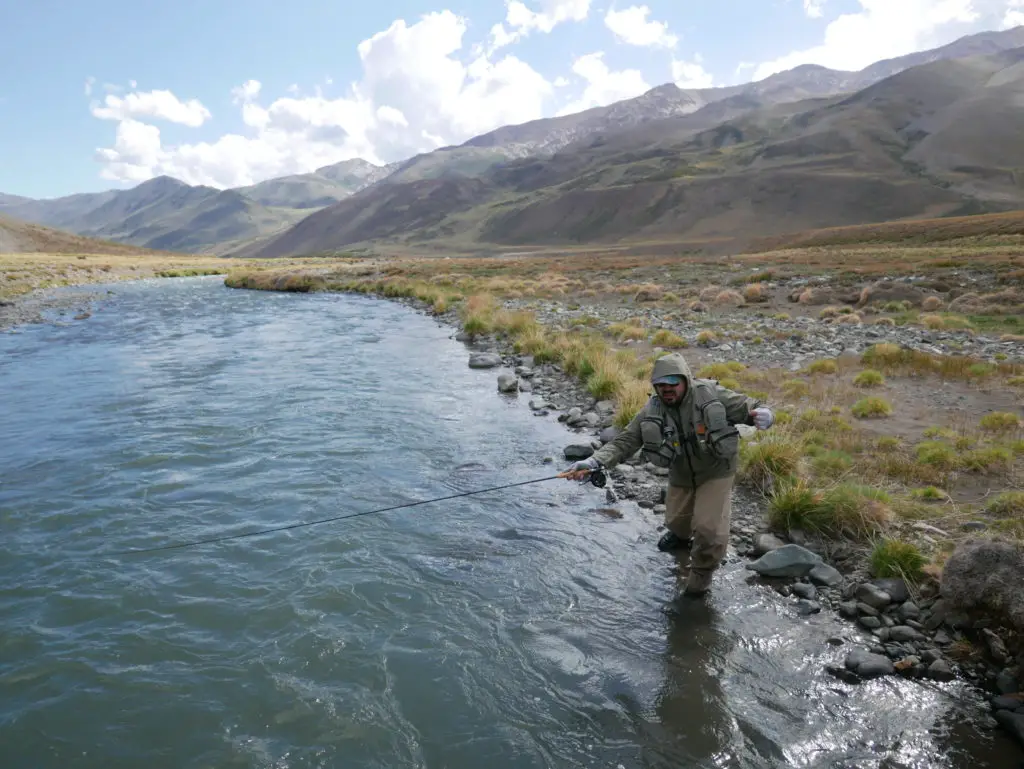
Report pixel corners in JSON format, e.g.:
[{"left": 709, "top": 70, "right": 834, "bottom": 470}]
[{"left": 665, "top": 475, "right": 735, "bottom": 571}]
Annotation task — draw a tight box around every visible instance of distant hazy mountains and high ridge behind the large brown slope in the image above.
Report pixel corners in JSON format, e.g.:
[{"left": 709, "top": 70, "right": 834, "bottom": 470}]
[{"left": 0, "top": 27, "right": 1024, "bottom": 253}]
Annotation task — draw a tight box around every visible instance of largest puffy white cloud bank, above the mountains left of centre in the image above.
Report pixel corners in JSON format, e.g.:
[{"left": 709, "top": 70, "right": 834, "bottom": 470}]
[{"left": 93, "top": 11, "right": 557, "bottom": 187}]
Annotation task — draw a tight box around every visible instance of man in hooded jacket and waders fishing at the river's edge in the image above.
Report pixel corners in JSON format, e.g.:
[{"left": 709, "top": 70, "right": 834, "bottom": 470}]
[{"left": 567, "top": 352, "right": 775, "bottom": 595}]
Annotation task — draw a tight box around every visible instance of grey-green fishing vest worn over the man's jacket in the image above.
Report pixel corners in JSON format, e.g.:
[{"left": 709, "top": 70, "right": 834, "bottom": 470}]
[{"left": 640, "top": 379, "right": 739, "bottom": 467}]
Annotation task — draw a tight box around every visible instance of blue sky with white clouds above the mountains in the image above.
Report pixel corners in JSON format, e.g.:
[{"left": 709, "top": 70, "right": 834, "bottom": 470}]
[{"left": 6, "top": 0, "right": 1024, "bottom": 198}]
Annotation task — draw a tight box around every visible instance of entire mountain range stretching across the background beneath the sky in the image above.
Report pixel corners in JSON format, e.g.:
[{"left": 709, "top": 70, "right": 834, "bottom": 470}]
[{"left": 0, "top": 27, "right": 1024, "bottom": 257}]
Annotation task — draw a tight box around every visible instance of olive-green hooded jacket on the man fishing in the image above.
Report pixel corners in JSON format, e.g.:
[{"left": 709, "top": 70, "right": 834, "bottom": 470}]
[{"left": 594, "top": 352, "right": 761, "bottom": 488}]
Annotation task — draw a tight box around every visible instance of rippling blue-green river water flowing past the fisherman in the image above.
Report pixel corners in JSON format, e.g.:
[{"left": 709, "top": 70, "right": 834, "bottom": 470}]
[{"left": 0, "top": 279, "right": 1020, "bottom": 769}]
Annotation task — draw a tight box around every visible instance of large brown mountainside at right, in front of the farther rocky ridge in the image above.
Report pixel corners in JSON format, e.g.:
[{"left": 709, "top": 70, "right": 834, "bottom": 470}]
[{"left": 246, "top": 49, "right": 1024, "bottom": 256}]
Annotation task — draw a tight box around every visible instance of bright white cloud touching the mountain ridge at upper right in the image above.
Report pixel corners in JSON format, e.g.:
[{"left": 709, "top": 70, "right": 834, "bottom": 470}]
[{"left": 754, "top": 0, "right": 999, "bottom": 80}]
